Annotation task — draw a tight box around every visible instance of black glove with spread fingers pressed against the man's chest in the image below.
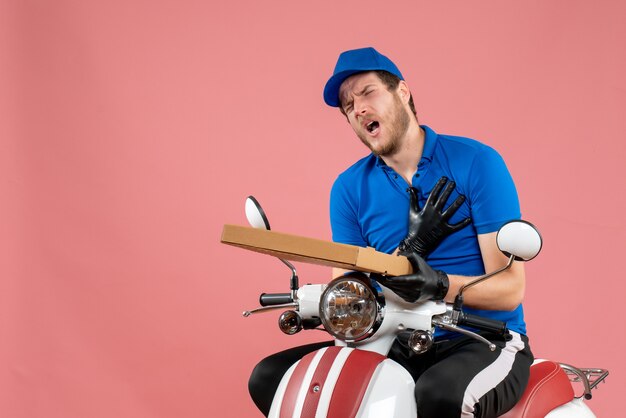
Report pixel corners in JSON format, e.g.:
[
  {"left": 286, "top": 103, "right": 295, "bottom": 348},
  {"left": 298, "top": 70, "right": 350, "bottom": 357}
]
[{"left": 398, "top": 177, "right": 472, "bottom": 257}]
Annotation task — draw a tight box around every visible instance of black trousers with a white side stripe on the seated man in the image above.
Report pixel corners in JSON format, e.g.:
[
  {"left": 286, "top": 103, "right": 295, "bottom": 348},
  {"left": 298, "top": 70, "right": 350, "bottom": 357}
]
[{"left": 248, "top": 333, "right": 533, "bottom": 418}]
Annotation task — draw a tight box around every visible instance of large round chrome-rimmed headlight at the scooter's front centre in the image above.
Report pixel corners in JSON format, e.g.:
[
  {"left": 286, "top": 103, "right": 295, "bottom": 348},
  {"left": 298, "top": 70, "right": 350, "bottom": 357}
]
[{"left": 320, "top": 275, "right": 380, "bottom": 342}]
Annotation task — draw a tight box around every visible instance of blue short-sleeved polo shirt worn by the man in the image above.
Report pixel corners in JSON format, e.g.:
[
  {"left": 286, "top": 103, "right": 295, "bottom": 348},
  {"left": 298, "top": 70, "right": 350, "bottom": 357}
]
[{"left": 330, "top": 126, "right": 526, "bottom": 334}]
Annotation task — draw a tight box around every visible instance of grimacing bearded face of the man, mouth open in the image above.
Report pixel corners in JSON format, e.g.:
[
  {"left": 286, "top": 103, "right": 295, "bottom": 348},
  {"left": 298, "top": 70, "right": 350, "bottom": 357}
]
[{"left": 339, "top": 72, "right": 410, "bottom": 157}]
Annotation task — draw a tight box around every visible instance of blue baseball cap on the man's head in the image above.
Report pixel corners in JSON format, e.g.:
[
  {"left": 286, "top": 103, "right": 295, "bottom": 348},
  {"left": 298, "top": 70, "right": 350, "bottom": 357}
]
[{"left": 324, "top": 47, "right": 404, "bottom": 107}]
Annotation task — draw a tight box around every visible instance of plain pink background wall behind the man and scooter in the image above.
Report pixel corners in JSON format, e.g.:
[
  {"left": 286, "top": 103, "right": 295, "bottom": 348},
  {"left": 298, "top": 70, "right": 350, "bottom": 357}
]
[{"left": 0, "top": 0, "right": 626, "bottom": 418}]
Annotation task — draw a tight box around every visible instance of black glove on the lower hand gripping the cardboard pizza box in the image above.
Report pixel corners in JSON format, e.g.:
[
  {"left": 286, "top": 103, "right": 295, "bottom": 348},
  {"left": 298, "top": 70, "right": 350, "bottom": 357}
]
[{"left": 370, "top": 253, "right": 450, "bottom": 303}]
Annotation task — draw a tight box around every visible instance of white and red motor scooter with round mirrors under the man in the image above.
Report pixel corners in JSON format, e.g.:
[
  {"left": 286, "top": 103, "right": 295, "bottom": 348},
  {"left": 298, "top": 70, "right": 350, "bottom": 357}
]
[{"left": 232, "top": 196, "right": 608, "bottom": 418}]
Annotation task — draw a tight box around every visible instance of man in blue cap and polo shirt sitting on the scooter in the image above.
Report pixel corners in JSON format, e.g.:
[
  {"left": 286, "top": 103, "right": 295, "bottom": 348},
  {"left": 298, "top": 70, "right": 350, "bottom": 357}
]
[{"left": 249, "top": 48, "right": 532, "bottom": 418}]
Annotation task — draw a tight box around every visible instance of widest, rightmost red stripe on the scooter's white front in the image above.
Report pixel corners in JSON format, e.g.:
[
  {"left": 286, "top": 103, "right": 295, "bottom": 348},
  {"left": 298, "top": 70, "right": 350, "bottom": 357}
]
[{"left": 326, "top": 350, "right": 387, "bottom": 418}]
